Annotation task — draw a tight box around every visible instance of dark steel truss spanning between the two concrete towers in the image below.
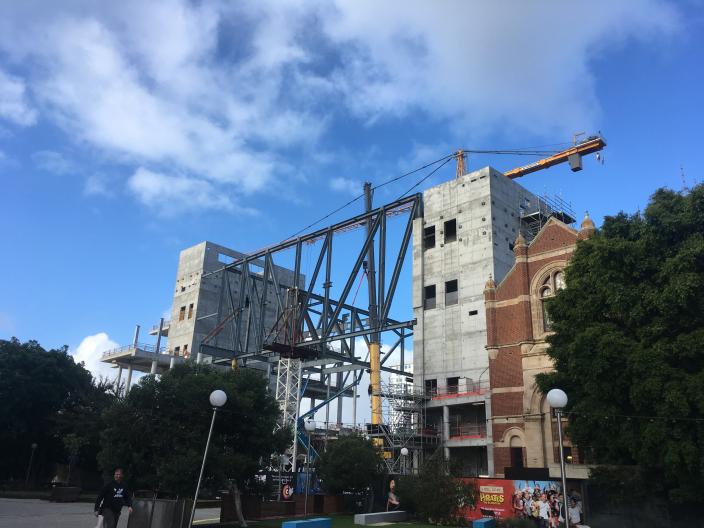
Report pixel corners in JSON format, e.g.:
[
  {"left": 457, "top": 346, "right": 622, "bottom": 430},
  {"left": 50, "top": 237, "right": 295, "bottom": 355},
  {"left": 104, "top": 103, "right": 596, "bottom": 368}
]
[{"left": 200, "top": 194, "right": 422, "bottom": 376}]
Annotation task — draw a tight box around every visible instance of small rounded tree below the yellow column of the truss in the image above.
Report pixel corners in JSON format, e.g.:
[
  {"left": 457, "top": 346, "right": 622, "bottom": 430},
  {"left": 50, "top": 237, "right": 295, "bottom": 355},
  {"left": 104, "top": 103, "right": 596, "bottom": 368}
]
[{"left": 316, "top": 435, "right": 383, "bottom": 493}]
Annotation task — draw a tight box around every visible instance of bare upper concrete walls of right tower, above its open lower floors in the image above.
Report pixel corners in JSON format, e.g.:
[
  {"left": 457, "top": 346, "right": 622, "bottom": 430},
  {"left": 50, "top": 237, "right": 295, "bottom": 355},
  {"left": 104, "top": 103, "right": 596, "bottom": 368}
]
[{"left": 413, "top": 167, "right": 537, "bottom": 391}]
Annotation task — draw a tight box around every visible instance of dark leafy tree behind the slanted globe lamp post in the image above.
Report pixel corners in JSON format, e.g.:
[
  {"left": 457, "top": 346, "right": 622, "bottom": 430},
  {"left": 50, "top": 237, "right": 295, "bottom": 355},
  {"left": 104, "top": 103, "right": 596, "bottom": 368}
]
[{"left": 99, "top": 363, "right": 290, "bottom": 496}]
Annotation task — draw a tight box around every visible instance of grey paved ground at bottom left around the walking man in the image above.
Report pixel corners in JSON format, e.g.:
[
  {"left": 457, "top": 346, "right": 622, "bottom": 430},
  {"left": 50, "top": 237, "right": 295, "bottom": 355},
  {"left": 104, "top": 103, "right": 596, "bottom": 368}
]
[{"left": 0, "top": 499, "right": 220, "bottom": 528}]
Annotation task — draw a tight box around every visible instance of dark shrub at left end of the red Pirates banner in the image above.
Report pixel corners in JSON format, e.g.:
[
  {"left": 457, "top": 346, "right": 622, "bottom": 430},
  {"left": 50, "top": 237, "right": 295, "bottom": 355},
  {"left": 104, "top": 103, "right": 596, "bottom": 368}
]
[{"left": 397, "top": 452, "right": 478, "bottom": 526}]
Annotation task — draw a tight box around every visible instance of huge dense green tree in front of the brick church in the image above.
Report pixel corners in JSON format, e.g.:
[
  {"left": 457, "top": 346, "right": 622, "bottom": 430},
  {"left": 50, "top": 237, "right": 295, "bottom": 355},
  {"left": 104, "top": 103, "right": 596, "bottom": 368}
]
[{"left": 538, "top": 185, "right": 704, "bottom": 502}]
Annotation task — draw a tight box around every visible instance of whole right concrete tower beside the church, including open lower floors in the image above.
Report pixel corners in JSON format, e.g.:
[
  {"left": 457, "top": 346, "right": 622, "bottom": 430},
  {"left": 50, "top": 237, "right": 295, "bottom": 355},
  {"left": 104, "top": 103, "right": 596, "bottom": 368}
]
[{"left": 413, "top": 167, "right": 573, "bottom": 476}]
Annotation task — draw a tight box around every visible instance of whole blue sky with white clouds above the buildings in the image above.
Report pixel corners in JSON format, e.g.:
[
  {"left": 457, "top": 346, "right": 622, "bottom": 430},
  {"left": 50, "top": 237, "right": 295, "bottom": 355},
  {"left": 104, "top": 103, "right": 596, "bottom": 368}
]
[{"left": 0, "top": 0, "right": 704, "bottom": 380}]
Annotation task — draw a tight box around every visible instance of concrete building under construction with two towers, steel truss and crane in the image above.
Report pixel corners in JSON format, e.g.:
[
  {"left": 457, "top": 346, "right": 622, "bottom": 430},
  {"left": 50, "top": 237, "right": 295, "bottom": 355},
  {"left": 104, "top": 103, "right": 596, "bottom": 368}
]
[{"left": 103, "top": 138, "right": 604, "bottom": 482}]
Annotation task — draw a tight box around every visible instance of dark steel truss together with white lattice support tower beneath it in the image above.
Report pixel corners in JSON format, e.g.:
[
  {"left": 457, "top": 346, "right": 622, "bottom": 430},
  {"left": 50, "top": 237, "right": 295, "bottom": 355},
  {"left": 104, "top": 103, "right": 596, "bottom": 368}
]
[{"left": 200, "top": 194, "right": 422, "bottom": 471}]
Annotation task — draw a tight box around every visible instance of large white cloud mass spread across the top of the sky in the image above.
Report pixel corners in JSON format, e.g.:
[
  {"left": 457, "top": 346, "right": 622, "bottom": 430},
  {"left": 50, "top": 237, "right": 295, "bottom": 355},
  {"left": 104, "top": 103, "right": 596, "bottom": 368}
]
[{"left": 0, "top": 0, "right": 680, "bottom": 210}]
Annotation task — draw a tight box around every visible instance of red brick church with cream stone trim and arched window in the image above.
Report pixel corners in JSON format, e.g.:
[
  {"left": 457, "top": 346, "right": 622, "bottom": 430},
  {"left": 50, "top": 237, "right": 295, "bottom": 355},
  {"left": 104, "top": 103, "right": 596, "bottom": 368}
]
[{"left": 484, "top": 215, "right": 595, "bottom": 479}]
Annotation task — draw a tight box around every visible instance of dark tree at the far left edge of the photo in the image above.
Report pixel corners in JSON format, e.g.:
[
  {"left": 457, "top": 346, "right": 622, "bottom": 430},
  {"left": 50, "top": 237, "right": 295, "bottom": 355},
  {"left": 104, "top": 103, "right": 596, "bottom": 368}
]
[{"left": 0, "top": 338, "right": 113, "bottom": 478}]
